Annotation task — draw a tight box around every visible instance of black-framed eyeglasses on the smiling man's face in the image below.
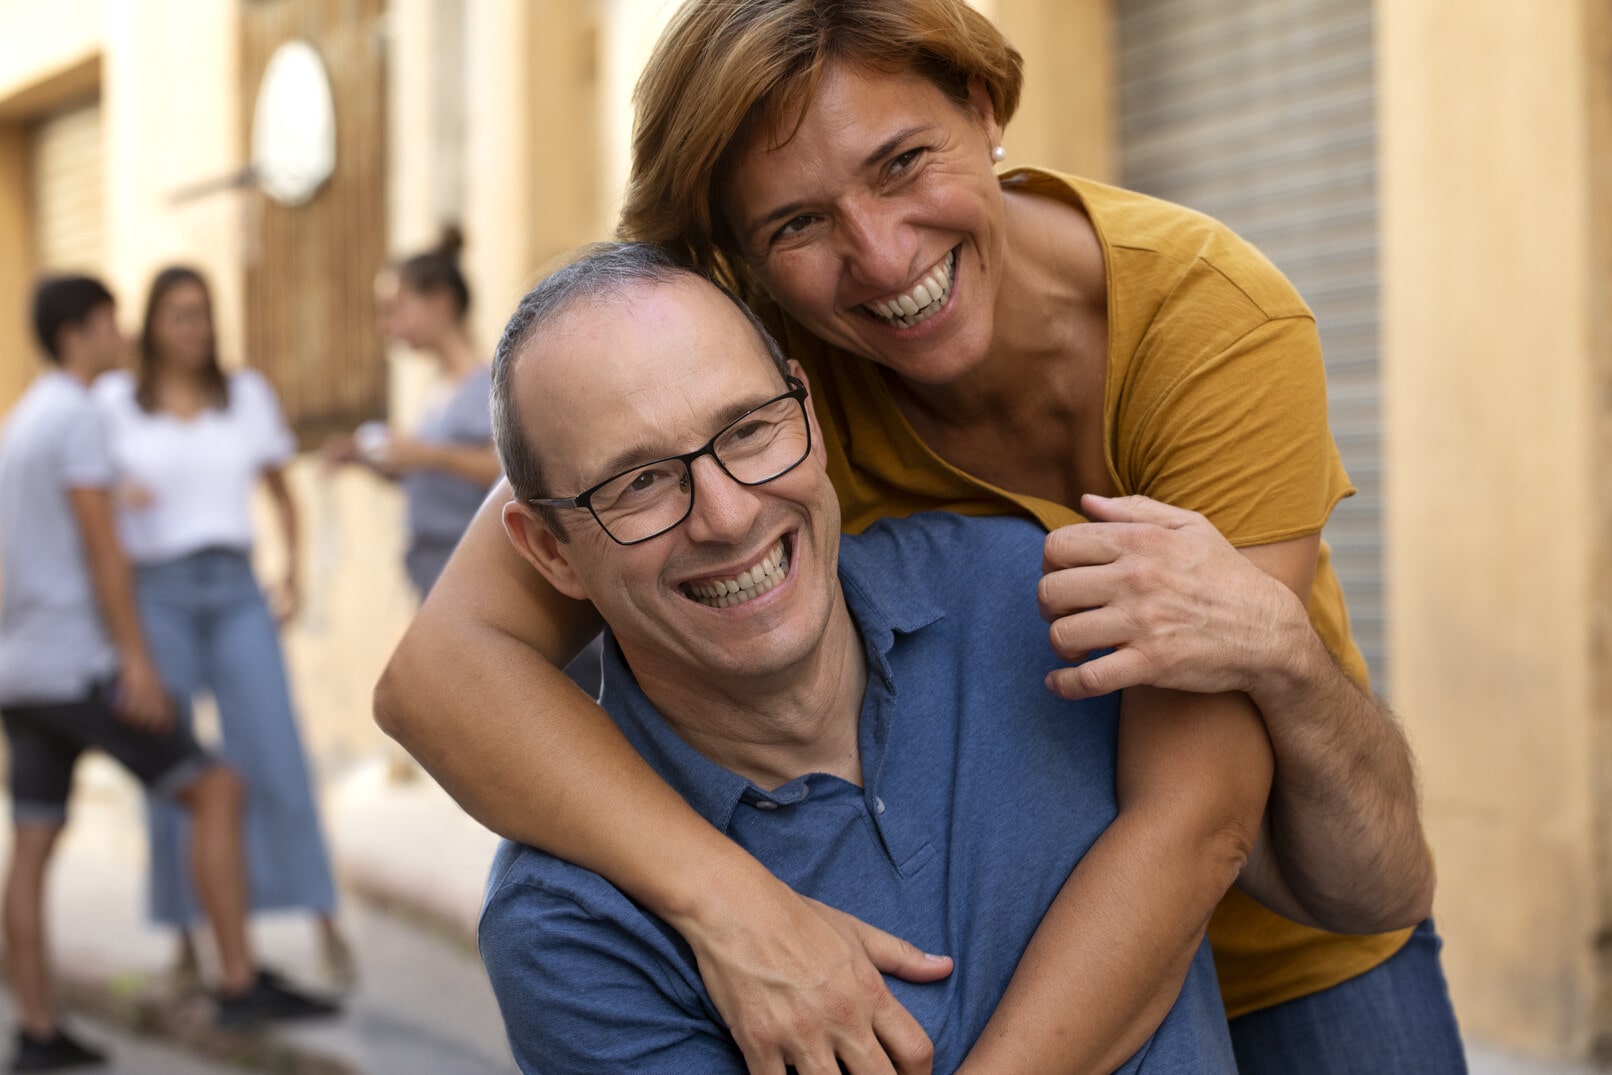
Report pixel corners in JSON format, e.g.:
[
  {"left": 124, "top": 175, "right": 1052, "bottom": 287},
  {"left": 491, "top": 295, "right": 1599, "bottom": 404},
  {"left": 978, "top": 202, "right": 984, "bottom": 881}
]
[{"left": 527, "top": 377, "right": 811, "bottom": 545}]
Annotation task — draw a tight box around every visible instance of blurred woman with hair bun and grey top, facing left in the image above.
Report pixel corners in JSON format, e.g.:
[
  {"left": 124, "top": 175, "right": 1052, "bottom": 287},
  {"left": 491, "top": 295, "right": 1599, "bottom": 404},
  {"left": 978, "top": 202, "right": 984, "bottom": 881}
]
[{"left": 324, "top": 226, "right": 600, "bottom": 695}]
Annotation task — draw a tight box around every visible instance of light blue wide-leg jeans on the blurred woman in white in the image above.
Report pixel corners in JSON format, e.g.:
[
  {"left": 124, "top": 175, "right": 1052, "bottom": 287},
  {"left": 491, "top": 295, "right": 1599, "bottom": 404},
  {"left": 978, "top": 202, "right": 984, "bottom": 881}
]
[{"left": 135, "top": 550, "right": 335, "bottom": 927}]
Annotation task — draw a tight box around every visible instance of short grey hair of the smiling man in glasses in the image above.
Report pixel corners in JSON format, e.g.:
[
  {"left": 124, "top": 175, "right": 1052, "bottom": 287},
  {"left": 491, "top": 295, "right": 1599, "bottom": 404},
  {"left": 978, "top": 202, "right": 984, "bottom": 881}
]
[{"left": 492, "top": 242, "right": 788, "bottom": 542}]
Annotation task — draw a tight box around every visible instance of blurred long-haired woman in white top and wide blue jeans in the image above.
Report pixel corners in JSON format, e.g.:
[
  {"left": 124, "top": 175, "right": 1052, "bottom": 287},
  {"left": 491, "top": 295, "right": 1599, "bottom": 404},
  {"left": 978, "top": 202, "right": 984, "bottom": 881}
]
[{"left": 95, "top": 266, "right": 353, "bottom": 985}]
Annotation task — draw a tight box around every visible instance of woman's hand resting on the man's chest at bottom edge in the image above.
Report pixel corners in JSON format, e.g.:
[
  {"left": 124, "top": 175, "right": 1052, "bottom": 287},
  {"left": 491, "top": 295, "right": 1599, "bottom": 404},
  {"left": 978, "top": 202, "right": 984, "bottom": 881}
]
[{"left": 688, "top": 898, "right": 951, "bottom": 1075}]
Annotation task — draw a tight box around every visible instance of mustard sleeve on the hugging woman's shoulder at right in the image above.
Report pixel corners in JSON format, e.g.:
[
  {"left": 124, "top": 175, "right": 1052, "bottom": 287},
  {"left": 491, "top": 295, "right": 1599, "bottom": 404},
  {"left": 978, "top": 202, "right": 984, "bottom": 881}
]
[{"left": 1109, "top": 296, "right": 1354, "bottom": 546}]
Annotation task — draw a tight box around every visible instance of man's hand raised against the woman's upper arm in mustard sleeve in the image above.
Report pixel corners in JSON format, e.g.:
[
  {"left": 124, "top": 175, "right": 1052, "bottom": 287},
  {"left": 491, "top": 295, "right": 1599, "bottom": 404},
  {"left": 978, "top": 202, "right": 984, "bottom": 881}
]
[{"left": 1037, "top": 496, "right": 1311, "bottom": 698}]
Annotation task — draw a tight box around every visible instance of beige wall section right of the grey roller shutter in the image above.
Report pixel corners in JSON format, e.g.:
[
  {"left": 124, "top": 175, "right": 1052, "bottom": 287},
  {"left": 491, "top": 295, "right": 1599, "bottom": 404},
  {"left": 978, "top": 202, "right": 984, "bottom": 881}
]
[{"left": 1377, "top": 0, "right": 1612, "bottom": 1056}]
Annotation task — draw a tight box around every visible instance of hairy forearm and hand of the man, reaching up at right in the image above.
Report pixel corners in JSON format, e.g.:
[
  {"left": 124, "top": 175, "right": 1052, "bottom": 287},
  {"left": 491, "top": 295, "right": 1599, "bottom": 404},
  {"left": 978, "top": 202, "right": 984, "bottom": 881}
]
[{"left": 1040, "top": 496, "right": 1433, "bottom": 933}]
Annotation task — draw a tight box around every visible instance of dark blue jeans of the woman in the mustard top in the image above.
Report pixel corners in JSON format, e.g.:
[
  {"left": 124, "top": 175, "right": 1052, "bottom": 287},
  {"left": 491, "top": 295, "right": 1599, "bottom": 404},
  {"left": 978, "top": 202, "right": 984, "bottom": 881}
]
[{"left": 1232, "top": 919, "right": 1467, "bottom": 1075}]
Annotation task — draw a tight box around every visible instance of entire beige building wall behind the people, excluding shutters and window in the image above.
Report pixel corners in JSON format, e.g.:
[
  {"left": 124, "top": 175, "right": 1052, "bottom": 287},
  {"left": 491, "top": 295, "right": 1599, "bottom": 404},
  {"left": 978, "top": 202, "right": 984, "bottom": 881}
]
[{"left": 0, "top": 0, "right": 1612, "bottom": 1056}]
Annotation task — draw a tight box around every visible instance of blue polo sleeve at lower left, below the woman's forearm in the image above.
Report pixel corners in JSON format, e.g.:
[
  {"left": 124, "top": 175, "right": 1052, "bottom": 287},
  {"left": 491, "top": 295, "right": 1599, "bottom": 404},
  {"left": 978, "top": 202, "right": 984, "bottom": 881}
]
[{"left": 477, "top": 863, "right": 745, "bottom": 1075}]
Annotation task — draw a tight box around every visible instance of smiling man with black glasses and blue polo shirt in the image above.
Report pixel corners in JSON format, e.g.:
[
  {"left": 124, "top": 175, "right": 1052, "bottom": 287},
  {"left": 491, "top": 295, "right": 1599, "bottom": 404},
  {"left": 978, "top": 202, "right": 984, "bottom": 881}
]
[{"left": 480, "top": 243, "right": 1250, "bottom": 1072}]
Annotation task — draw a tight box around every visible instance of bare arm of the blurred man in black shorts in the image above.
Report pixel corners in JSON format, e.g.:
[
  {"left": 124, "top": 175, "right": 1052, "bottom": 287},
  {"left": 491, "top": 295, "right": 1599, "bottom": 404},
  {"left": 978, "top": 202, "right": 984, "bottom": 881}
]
[{"left": 68, "top": 488, "right": 174, "bottom": 732}]
